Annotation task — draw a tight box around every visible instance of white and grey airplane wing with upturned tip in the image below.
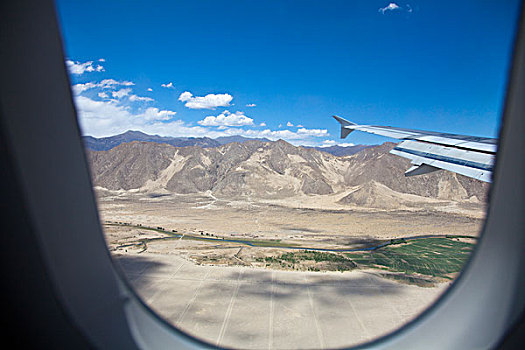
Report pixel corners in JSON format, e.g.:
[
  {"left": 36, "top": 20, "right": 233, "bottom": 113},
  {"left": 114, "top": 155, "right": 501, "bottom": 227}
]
[{"left": 333, "top": 115, "right": 498, "bottom": 182}]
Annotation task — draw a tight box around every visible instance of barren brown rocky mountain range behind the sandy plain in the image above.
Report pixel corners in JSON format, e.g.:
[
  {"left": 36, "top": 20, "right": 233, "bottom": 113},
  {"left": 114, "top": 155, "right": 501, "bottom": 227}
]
[{"left": 88, "top": 140, "right": 488, "bottom": 207}]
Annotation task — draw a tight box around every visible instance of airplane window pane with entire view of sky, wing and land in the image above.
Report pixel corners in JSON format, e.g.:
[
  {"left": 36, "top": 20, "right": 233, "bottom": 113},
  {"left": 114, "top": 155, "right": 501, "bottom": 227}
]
[{"left": 57, "top": 0, "right": 519, "bottom": 349}]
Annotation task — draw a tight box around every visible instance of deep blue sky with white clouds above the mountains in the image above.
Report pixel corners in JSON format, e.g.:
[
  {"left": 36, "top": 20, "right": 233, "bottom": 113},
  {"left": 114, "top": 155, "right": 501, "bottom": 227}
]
[{"left": 57, "top": 0, "right": 518, "bottom": 145}]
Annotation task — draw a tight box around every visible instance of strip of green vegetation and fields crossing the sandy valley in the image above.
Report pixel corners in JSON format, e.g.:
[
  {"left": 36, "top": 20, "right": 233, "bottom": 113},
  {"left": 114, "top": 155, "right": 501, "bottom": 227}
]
[{"left": 106, "top": 223, "right": 476, "bottom": 286}]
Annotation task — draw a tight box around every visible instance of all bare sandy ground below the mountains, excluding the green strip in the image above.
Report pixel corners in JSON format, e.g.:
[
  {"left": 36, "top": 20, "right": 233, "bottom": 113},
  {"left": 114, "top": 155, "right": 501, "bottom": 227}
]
[{"left": 99, "top": 195, "right": 483, "bottom": 349}]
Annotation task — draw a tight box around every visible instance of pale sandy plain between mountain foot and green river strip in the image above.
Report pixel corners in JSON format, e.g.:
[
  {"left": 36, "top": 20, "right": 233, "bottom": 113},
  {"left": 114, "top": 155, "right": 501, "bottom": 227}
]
[{"left": 99, "top": 191, "right": 483, "bottom": 240}]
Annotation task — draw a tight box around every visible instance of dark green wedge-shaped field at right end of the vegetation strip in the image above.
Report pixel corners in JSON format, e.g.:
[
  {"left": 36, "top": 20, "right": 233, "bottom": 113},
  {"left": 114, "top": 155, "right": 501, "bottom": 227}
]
[{"left": 346, "top": 238, "right": 474, "bottom": 279}]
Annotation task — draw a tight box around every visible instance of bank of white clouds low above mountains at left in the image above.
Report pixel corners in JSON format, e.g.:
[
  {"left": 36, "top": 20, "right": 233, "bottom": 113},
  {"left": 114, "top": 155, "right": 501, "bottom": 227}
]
[{"left": 70, "top": 64, "right": 329, "bottom": 145}]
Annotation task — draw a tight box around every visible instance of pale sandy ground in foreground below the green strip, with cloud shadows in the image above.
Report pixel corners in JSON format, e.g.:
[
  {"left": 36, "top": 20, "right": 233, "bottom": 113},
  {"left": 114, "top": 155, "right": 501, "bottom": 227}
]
[{"left": 115, "top": 252, "right": 448, "bottom": 349}]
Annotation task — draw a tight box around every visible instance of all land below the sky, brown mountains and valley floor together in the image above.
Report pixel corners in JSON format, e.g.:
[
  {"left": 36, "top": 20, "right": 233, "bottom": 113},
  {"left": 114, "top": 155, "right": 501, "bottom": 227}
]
[{"left": 89, "top": 141, "right": 488, "bottom": 349}]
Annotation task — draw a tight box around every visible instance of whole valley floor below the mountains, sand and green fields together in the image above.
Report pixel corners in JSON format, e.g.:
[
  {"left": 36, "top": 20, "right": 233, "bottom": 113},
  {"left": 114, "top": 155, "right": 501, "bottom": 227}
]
[{"left": 99, "top": 191, "right": 484, "bottom": 349}]
